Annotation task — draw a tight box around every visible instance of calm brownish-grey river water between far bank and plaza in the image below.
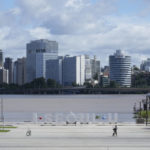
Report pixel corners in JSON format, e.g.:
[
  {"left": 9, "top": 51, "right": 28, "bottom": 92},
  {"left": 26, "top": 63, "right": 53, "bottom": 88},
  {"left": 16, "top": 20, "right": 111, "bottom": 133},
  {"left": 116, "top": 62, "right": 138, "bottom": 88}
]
[{"left": 1, "top": 95, "right": 146, "bottom": 122}]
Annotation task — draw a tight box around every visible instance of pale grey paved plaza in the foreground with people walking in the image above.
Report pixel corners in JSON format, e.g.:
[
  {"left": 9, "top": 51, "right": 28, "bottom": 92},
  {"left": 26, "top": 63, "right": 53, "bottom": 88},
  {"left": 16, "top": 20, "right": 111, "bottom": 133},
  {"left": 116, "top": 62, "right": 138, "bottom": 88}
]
[{"left": 0, "top": 124, "right": 150, "bottom": 150}]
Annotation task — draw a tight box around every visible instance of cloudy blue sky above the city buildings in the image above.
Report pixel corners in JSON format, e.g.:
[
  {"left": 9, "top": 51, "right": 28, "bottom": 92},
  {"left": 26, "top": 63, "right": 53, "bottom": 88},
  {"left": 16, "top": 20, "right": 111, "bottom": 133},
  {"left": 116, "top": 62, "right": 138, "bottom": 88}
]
[{"left": 0, "top": 0, "right": 150, "bottom": 66}]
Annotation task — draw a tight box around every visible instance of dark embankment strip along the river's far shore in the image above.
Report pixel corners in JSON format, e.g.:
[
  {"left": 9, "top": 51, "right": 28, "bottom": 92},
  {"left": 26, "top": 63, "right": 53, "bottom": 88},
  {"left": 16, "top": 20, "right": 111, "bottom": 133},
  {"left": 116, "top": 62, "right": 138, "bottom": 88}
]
[{"left": 0, "top": 87, "right": 150, "bottom": 95}]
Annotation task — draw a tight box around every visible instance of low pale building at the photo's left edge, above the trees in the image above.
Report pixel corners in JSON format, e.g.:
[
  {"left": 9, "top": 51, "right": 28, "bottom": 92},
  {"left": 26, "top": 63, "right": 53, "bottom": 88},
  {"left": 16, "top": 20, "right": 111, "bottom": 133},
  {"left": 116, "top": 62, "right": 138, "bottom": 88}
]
[{"left": 0, "top": 68, "right": 9, "bottom": 84}]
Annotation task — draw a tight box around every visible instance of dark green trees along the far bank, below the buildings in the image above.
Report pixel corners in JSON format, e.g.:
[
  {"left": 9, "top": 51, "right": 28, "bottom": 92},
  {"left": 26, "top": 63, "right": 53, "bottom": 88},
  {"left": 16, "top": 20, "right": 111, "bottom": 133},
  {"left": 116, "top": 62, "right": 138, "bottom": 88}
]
[{"left": 0, "top": 72, "right": 150, "bottom": 89}]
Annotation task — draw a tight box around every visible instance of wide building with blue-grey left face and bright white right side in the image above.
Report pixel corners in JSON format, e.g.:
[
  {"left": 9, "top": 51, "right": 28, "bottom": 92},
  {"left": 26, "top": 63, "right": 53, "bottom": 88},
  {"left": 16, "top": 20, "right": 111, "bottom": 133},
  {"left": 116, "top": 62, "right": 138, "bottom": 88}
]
[{"left": 63, "top": 56, "right": 85, "bottom": 86}]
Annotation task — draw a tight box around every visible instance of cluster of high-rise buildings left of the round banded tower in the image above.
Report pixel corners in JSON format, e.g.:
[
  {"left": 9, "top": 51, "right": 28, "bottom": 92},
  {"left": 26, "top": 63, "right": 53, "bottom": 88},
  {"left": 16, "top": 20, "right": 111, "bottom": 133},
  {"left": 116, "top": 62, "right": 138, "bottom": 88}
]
[{"left": 0, "top": 39, "right": 101, "bottom": 86}]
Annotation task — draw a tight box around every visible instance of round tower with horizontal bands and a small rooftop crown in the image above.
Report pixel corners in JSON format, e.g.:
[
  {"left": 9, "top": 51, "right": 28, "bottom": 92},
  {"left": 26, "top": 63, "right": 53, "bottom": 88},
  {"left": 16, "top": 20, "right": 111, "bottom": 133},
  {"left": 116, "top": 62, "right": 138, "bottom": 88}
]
[{"left": 109, "top": 50, "right": 131, "bottom": 87}]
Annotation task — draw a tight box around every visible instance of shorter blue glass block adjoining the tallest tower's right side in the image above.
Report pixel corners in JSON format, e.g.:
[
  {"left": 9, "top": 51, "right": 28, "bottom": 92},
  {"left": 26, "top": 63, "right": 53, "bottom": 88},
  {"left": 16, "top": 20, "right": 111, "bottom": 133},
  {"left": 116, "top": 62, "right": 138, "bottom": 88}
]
[{"left": 46, "top": 57, "right": 63, "bottom": 85}]
